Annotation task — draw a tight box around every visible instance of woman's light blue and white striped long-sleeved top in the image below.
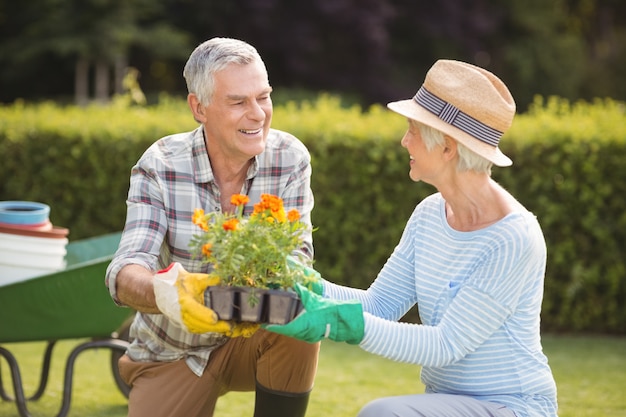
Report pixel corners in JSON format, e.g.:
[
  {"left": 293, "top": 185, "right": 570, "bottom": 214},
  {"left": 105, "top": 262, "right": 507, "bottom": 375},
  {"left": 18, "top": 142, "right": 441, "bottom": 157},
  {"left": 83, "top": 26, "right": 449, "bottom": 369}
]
[{"left": 324, "top": 193, "right": 557, "bottom": 417}]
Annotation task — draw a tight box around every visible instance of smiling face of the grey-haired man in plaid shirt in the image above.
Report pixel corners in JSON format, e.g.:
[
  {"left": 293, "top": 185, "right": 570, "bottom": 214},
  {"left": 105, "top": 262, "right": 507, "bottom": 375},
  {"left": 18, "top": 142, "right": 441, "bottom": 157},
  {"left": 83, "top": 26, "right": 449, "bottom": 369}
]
[{"left": 199, "top": 62, "right": 273, "bottom": 162}]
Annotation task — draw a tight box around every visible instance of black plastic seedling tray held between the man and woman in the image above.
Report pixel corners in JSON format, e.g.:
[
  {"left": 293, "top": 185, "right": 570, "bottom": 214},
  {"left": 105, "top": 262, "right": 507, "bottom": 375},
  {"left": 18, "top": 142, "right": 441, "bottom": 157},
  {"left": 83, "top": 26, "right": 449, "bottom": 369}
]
[{"left": 204, "top": 286, "right": 302, "bottom": 324}]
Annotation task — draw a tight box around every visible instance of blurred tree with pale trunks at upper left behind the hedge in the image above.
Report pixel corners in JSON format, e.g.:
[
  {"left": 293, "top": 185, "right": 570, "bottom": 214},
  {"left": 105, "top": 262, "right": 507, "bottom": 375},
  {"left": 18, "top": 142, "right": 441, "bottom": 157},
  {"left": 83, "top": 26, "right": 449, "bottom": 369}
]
[{"left": 0, "top": 0, "right": 188, "bottom": 104}]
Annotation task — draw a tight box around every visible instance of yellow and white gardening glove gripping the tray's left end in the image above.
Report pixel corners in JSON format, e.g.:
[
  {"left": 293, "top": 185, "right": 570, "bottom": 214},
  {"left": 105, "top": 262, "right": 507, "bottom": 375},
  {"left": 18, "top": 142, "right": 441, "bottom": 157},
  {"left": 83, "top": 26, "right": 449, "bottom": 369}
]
[{"left": 154, "top": 262, "right": 259, "bottom": 337}]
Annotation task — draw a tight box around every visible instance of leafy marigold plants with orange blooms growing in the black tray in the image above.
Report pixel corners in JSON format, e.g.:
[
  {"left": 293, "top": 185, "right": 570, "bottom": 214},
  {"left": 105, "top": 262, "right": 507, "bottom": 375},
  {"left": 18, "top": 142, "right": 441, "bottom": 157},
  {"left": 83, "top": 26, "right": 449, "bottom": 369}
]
[{"left": 190, "top": 194, "right": 309, "bottom": 290}]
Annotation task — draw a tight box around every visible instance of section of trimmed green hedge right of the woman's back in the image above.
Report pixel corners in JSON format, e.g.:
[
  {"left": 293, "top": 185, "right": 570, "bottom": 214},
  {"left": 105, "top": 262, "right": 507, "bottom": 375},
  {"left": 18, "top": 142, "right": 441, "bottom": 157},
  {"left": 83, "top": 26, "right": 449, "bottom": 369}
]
[{"left": 496, "top": 98, "right": 626, "bottom": 333}]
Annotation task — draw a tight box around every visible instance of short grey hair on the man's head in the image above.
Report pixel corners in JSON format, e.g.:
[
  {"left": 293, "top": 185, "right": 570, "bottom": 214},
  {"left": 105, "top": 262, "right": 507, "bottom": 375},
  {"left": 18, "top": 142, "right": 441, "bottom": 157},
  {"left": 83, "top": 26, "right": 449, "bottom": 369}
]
[{"left": 183, "top": 38, "right": 265, "bottom": 106}]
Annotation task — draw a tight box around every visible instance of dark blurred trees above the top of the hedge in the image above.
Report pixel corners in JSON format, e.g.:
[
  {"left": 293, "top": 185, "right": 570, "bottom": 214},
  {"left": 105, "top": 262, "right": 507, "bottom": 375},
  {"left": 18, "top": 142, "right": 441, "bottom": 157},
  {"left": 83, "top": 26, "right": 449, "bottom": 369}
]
[{"left": 0, "top": 0, "right": 626, "bottom": 111}]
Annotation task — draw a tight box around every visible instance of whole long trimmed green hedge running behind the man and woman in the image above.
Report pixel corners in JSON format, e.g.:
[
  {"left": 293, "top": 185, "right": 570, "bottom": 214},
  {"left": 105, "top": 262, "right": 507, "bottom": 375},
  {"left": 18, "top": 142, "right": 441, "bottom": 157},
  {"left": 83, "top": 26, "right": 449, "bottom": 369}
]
[{"left": 0, "top": 95, "right": 626, "bottom": 334}]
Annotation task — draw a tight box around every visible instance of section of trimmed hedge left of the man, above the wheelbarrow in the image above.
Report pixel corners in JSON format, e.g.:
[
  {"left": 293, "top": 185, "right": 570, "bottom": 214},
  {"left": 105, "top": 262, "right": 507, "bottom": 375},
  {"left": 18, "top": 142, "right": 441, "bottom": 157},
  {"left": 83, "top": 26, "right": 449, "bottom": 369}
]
[{"left": 0, "top": 95, "right": 195, "bottom": 239}]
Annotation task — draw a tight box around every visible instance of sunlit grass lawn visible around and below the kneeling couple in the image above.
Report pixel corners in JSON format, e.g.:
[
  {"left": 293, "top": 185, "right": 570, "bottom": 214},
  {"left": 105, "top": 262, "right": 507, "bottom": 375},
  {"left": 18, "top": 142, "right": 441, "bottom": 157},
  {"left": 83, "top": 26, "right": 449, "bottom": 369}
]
[{"left": 0, "top": 335, "right": 626, "bottom": 417}]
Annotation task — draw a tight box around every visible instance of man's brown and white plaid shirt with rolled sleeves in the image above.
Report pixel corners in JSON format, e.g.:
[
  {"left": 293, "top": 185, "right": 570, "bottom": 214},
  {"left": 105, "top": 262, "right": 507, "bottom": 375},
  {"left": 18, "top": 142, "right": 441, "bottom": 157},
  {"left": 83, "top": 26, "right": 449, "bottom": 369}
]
[{"left": 106, "top": 127, "right": 313, "bottom": 375}]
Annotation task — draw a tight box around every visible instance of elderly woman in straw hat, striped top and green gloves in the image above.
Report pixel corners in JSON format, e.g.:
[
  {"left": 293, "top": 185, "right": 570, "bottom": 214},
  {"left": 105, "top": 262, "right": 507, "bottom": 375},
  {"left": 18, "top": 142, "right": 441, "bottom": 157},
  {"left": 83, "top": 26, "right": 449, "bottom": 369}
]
[{"left": 269, "top": 60, "right": 557, "bottom": 417}]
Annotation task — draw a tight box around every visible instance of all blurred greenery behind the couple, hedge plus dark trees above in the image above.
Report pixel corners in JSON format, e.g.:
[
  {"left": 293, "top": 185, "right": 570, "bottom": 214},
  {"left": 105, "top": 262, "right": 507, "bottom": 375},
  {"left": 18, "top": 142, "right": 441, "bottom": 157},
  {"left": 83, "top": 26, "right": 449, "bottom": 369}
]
[{"left": 0, "top": 0, "right": 626, "bottom": 334}]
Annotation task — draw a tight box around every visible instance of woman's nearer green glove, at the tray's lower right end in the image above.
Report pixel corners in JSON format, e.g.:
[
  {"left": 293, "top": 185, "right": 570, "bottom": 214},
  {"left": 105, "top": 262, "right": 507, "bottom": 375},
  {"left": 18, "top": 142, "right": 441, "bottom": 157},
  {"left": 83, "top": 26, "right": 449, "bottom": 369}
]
[{"left": 265, "top": 283, "right": 365, "bottom": 345}]
